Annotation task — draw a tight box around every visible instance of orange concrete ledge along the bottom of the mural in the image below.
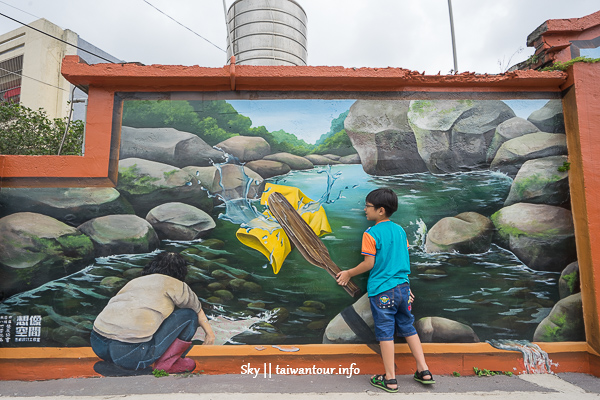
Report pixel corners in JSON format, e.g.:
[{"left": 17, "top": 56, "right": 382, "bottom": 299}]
[{"left": 0, "top": 342, "right": 600, "bottom": 381}]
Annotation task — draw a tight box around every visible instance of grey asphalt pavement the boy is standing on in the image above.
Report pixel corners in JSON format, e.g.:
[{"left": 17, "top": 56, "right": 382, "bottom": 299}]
[{"left": 0, "top": 373, "right": 600, "bottom": 400}]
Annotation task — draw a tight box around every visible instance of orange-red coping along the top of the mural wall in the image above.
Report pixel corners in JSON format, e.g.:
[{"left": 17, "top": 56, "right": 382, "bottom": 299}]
[{"left": 62, "top": 56, "right": 568, "bottom": 91}]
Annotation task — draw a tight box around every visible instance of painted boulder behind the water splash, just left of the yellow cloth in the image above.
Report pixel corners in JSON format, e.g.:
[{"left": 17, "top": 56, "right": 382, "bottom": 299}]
[{"left": 183, "top": 164, "right": 265, "bottom": 200}]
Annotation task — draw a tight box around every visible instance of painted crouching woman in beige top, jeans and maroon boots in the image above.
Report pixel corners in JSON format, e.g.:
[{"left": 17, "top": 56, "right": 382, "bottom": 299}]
[{"left": 91, "top": 253, "right": 215, "bottom": 373}]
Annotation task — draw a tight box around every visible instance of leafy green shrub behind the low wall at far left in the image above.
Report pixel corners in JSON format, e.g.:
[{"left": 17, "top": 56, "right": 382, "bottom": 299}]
[{"left": 0, "top": 102, "right": 84, "bottom": 155}]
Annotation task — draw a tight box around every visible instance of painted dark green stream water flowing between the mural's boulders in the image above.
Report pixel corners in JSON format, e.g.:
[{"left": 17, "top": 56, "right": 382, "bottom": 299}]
[{"left": 0, "top": 165, "right": 559, "bottom": 346}]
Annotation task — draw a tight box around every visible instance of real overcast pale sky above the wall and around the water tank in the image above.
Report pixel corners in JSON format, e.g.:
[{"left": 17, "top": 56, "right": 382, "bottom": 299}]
[{"left": 0, "top": 0, "right": 600, "bottom": 74}]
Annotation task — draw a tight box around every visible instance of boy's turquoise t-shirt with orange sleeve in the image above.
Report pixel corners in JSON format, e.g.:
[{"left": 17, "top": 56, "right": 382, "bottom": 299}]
[{"left": 361, "top": 220, "right": 410, "bottom": 297}]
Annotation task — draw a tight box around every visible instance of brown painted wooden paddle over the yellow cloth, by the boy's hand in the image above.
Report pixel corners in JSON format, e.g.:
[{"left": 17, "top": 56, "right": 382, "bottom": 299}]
[{"left": 268, "top": 192, "right": 360, "bottom": 297}]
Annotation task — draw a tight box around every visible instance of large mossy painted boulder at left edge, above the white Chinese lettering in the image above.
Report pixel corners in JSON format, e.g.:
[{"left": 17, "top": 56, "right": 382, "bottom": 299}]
[{"left": 0, "top": 212, "right": 94, "bottom": 296}]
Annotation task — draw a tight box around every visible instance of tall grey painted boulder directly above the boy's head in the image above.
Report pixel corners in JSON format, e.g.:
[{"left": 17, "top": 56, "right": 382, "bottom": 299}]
[{"left": 344, "top": 100, "right": 427, "bottom": 175}]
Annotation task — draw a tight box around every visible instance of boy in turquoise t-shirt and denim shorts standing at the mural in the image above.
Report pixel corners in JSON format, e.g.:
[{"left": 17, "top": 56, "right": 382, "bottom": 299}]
[{"left": 337, "top": 188, "right": 435, "bottom": 392}]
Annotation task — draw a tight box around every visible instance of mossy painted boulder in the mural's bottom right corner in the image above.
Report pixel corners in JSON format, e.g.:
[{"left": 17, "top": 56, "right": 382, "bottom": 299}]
[{"left": 533, "top": 293, "right": 585, "bottom": 342}]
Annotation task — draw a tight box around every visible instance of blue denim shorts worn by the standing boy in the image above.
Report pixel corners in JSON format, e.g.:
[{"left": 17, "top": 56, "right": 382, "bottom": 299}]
[{"left": 369, "top": 283, "right": 417, "bottom": 342}]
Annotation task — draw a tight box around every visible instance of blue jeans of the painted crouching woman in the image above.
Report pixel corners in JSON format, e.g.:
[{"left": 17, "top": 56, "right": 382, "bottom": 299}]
[{"left": 90, "top": 308, "right": 198, "bottom": 370}]
